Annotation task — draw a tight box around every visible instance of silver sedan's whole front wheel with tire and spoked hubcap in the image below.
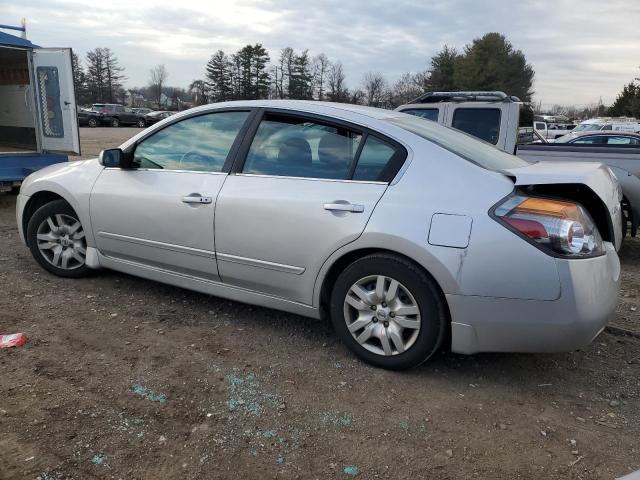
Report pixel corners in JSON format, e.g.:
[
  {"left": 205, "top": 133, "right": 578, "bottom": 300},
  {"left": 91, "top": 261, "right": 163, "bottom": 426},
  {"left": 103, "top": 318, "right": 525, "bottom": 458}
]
[{"left": 27, "top": 200, "right": 89, "bottom": 278}]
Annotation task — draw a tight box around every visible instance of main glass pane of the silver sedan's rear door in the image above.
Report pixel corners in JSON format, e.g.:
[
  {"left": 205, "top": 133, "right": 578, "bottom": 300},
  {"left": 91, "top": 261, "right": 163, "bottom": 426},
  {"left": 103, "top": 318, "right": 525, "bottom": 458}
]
[{"left": 243, "top": 114, "right": 362, "bottom": 180}]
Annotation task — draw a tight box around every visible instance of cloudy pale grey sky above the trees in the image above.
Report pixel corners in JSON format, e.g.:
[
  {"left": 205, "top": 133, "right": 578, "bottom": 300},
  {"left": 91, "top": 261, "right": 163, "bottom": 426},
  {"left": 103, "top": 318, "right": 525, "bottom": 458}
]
[{"left": 0, "top": 0, "right": 640, "bottom": 106}]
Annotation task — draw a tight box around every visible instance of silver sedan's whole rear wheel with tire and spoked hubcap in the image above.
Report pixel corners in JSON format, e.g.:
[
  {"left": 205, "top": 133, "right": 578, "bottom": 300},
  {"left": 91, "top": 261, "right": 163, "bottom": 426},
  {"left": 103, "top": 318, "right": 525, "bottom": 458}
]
[{"left": 330, "top": 253, "right": 447, "bottom": 370}]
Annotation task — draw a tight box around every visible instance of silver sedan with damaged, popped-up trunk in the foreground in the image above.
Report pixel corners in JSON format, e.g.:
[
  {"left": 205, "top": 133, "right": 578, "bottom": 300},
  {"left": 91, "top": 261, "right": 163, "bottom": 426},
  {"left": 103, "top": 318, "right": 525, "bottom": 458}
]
[{"left": 17, "top": 100, "right": 621, "bottom": 369}]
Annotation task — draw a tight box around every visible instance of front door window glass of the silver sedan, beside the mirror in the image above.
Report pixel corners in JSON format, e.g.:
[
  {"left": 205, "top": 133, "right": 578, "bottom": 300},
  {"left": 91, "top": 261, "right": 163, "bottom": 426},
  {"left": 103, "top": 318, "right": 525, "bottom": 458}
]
[{"left": 132, "top": 112, "right": 249, "bottom": 172}]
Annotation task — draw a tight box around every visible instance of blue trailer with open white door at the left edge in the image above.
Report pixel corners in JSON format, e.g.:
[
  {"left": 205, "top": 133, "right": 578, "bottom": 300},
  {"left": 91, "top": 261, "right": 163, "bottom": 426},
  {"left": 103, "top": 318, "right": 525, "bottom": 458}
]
[{"left": 0, "top": 25, "right": 80, "bottom": 191}]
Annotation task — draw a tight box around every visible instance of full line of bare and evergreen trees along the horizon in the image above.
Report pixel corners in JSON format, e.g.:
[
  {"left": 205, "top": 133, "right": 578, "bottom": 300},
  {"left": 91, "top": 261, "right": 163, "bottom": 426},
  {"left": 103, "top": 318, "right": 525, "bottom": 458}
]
[{"left": 73, "top": 33, "right": 534, "bottom": 108}]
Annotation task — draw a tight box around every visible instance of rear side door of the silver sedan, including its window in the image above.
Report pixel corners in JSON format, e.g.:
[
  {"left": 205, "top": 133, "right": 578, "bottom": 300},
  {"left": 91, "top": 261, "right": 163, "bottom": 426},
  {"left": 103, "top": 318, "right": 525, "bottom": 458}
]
[{"left": 215, "top": 112, "right": 406, "bottom": 304}]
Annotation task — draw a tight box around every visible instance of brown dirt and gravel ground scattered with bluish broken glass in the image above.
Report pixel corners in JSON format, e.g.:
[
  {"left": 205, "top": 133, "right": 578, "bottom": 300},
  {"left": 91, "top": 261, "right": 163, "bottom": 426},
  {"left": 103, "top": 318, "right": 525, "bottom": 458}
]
[{"left": 0, "top": 129, "right": 640, "bottom": 480}]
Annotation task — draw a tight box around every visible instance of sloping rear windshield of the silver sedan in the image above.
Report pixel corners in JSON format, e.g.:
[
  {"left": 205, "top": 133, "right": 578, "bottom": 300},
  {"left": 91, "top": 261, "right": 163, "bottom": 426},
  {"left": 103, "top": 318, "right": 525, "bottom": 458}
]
[{"left": 385, "top": 115, "right": 529, "bottom": 171}]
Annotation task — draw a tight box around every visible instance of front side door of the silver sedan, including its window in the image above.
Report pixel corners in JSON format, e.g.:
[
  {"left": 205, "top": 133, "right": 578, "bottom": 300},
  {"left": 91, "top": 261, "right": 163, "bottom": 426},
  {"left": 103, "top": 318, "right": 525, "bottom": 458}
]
[{"left": 90, "top": 111, "right": 249, "bottom": 280}]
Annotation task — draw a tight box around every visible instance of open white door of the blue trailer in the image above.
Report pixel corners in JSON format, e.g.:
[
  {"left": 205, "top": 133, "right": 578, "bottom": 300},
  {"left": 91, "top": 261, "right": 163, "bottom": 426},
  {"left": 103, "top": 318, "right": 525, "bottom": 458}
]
[{"left": 32, "top": 48, "right": 80, "bottom": 154}]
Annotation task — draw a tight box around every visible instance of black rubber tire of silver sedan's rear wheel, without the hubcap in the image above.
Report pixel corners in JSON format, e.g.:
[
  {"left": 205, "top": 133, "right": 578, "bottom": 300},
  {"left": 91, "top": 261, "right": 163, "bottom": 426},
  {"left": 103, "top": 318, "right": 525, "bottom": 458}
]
[{"left": 329, "top": 253, "right": 449, "bottom": 370}]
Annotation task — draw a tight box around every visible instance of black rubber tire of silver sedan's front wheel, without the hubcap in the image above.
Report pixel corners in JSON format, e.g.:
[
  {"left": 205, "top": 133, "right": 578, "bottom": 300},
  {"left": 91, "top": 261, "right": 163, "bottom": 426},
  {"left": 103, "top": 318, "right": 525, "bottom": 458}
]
[{"left": 26, "top": 200, "right": 91, "bottom": 278}]
